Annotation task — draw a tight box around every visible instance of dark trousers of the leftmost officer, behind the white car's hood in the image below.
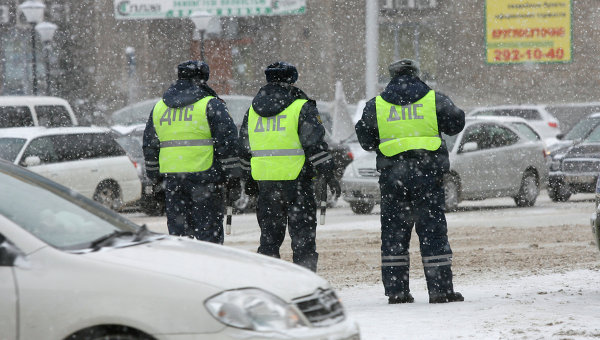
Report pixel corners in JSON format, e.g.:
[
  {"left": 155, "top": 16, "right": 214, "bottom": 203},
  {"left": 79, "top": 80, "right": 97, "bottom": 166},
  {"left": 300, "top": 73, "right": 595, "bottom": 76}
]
[{"left": 165, "top": 175, "right": 224, "bottom": 244}]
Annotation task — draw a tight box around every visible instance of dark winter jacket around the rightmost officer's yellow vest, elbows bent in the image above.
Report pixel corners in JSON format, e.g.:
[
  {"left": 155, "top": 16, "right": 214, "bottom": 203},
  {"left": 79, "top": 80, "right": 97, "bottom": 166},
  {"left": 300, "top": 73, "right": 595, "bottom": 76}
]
[{"left": 355, "top": 75, "right": 465, "bottom": 172}]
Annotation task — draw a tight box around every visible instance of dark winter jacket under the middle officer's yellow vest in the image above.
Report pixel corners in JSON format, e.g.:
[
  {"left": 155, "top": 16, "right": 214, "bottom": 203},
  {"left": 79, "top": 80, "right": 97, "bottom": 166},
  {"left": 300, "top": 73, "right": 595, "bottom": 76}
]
[{"left": 240, "top": 83, "right": 335, "bottom": 180}]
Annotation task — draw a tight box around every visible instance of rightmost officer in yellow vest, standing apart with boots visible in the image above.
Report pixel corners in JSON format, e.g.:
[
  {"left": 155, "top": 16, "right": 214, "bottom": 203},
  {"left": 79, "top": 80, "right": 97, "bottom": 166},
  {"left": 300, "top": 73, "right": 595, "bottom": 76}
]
[{"left": 355, "top": 59, "right": 465, "bottom": 304}]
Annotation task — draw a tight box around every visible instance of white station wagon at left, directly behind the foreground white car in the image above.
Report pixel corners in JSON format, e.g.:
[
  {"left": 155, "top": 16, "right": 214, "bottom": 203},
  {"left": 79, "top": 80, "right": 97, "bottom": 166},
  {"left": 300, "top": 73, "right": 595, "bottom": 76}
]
[{"left": 0, "top": 127, "right": 141, "bottom": 210}]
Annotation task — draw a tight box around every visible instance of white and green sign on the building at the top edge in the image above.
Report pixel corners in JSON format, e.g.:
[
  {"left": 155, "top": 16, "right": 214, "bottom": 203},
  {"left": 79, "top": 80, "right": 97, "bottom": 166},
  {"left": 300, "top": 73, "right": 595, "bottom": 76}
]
[{"left": 114, "top": 0, "right": 306, "bottom": 20}]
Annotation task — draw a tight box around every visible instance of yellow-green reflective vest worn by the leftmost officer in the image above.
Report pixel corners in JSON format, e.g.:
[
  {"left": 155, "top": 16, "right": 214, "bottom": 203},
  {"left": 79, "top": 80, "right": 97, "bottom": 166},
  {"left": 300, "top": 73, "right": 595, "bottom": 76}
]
[{"left": 152, "top": 96, "right": 214, "bottom": 173}]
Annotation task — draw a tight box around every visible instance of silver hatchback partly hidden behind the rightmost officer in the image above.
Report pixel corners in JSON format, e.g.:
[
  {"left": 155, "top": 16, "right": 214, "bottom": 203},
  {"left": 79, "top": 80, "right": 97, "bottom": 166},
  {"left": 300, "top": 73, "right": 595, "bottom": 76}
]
[{"left": 342, "top": 117, "right": 548, "bottom": 214}]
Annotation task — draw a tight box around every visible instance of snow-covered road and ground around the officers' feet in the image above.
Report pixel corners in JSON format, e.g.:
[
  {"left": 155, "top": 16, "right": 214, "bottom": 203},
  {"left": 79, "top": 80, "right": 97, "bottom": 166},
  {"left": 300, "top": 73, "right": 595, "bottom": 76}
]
[{"left": 128, "top": 192, "right": 600, "bottom": 340}]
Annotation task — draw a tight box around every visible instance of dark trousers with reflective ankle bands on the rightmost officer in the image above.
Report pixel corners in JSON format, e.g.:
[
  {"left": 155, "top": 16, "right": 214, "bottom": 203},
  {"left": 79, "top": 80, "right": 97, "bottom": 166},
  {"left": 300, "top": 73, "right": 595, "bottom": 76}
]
[{"left": 379, "top": 159, "right": 453, "bottom": 296}]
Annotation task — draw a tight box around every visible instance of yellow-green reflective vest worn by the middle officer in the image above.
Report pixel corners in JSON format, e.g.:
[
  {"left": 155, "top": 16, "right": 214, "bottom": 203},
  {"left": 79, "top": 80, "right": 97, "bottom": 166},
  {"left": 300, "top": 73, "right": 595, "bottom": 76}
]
[{"left": 248, "top": 99, "right": 307, "bottom": 181}]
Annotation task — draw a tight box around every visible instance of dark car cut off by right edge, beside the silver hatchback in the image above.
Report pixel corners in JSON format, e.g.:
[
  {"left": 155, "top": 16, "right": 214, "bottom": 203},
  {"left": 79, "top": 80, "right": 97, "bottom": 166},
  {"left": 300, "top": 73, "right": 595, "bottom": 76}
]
[{"left": 548, "top": 125, "right": 600, "bottom": 202}]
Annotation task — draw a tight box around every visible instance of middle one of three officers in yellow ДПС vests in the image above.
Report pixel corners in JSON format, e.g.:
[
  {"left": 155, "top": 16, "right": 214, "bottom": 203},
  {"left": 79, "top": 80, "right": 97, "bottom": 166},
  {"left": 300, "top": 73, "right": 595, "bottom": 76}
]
[{"left": 240, "top": 62, "right": 341, "bottom": 271}]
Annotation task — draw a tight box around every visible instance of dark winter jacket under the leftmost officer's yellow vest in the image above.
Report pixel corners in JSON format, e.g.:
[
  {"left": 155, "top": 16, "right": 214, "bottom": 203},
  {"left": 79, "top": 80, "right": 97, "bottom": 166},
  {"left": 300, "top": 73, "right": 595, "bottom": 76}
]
[{"left": 143, "top": 79, "right": 240, "bottom": 183}]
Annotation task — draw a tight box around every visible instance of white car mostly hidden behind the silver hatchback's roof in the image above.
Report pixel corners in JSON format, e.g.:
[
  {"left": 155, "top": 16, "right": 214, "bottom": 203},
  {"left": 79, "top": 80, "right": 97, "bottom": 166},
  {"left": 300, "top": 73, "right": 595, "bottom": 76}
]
[{"left": 468, "top": 105, "right": 561, "bottom": 146}]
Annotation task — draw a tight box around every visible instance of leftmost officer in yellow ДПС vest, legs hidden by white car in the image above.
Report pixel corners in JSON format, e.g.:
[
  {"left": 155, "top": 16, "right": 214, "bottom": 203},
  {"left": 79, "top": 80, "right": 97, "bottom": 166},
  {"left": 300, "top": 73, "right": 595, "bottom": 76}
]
[{"left": 143, "top": 60, "right": 241, "bottom": 244}]
